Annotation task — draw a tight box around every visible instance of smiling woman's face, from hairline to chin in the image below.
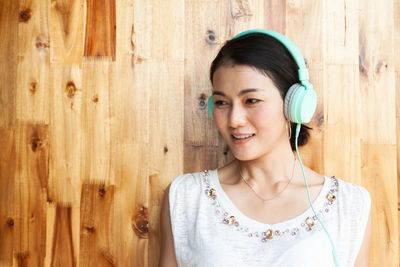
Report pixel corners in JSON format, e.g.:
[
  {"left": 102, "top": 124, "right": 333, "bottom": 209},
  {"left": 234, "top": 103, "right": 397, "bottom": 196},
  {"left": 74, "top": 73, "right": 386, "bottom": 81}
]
[{"left": 213, "top": 65, "right": 289, "bottom": 160}]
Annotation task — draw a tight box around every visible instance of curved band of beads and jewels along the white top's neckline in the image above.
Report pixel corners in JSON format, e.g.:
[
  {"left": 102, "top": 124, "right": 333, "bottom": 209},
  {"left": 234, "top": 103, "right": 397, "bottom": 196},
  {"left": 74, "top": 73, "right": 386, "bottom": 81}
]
[{"left": 201, "top": 170, "right": 339, "bottom": 242}]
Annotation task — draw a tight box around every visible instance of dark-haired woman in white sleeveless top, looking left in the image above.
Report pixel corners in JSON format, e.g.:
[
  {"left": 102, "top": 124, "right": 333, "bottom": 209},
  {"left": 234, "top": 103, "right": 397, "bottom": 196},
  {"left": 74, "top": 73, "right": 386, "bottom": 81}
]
[{"left": 160, "top": 30, "right": 372, "bottom": 267}]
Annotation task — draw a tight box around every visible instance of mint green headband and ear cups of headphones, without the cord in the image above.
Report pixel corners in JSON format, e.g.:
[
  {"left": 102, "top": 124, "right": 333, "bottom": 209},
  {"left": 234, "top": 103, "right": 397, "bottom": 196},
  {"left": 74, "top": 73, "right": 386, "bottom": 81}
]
[{"left": 208, "top": 29, "right": 317, "bottom": 123}]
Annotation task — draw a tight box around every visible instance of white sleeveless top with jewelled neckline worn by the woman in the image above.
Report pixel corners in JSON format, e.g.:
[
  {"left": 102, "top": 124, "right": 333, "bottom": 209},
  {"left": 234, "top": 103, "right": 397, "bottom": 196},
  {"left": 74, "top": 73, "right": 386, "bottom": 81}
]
[{"left": 169, "top": 169, "right": 371, "bottom": 267}]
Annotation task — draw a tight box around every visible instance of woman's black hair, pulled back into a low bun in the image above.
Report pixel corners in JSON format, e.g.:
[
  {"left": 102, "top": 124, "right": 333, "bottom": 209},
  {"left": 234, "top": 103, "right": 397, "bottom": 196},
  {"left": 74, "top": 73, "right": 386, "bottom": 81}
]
[{"left": 210, "top": 33, "right": 312, "bottom": 151}]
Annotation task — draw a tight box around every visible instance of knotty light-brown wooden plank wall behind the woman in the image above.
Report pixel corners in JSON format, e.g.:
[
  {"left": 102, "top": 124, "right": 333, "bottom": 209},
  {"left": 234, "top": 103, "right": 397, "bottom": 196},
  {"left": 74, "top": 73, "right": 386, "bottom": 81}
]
[{"left": 0, "top": 0, "right": 400, "bottom": 266}]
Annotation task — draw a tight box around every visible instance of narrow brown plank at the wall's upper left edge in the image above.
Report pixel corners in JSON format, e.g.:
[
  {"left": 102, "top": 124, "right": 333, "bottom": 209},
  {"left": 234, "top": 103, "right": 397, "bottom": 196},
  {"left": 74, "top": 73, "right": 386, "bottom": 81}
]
[{"left": 0, "top": 0, "right": 19, "bottom": 127}]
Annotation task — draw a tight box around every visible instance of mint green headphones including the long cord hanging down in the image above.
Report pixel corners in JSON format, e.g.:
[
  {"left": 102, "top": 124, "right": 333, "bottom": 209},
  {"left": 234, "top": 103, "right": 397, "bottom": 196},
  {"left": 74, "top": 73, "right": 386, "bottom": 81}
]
[{"left": 208, "top": 29, "right": 340, "bottom": 267}]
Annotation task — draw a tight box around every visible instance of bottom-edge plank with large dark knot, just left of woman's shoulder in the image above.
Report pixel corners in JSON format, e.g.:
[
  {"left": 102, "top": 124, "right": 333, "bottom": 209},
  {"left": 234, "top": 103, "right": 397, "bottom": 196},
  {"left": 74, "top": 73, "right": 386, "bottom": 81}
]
[{"left": 111, "top": 143, "right": 149, "bottom": 266}]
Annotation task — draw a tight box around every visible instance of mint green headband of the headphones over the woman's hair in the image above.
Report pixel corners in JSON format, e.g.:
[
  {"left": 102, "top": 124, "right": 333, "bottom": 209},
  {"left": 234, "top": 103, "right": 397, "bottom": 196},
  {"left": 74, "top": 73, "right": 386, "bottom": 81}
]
[{"left": 232, "top": 29, "right": 309, "bottom": 84}]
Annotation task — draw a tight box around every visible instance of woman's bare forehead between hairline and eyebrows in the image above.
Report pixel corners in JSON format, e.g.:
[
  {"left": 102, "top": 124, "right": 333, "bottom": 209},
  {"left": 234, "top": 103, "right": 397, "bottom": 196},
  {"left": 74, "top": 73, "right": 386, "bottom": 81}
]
[{"left": 213, "top": 65, "right": 278, "bottom": 94}]
